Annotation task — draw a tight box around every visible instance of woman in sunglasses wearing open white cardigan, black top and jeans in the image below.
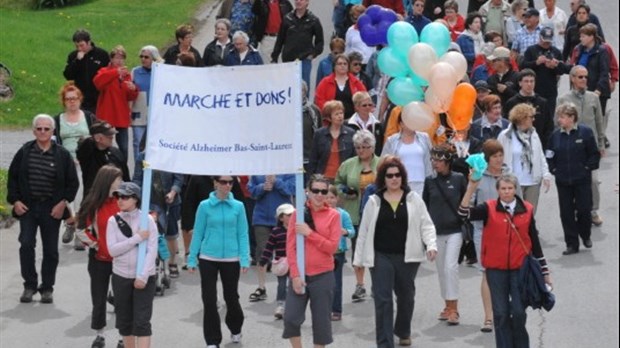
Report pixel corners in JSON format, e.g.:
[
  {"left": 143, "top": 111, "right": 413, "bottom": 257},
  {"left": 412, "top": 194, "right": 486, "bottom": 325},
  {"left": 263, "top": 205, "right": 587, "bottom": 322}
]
[{"left": 353, "top": 158, "right": 437, "bottom": 348}]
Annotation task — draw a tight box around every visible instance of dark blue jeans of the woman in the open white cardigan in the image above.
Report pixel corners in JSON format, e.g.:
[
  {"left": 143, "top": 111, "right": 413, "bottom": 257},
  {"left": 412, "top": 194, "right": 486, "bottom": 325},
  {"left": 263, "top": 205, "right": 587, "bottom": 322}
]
[{"left": 370, "top": 251, "right": 420, "bottom": 348}]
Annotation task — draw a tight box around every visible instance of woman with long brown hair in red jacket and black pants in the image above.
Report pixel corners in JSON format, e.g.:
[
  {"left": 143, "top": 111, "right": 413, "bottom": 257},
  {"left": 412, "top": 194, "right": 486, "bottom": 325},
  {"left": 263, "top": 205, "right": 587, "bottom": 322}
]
[{"left": 77, "top": 165, "right": 123, "bottom": 348}]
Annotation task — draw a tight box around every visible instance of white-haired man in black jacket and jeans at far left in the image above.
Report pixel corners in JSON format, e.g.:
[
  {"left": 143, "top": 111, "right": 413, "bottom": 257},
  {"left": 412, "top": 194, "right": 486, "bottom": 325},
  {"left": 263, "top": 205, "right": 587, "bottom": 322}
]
[{"left": 7, "top": 114, "right": 80, "bottom": 303}]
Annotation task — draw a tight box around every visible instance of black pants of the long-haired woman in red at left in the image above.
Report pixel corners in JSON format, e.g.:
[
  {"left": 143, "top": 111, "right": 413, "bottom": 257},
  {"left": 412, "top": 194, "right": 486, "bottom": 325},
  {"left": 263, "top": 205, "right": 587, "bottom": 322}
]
[{"left": 88, "top": 249, "right": 112, "bottom": 330}]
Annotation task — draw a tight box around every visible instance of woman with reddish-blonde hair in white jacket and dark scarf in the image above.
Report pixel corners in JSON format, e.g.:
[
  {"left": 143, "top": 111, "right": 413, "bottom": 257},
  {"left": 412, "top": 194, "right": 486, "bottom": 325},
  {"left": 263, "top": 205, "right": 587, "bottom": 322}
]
[{"left": 497, "top": 104, "right": 551, "bottom": 213}]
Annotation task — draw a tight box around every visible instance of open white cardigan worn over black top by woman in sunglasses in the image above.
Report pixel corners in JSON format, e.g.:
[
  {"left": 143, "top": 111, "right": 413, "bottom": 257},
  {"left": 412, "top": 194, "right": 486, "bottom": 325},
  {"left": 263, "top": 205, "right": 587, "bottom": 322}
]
[{"left": 353, "top": 191, "right": 437, "bottom": 267}]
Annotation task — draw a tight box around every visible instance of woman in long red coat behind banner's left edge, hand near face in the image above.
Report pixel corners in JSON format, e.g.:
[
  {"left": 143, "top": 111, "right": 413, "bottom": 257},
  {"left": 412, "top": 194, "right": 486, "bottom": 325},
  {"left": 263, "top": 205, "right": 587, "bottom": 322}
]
[{"left": 93, "top": 45, "right": 139, "bottom": 161}]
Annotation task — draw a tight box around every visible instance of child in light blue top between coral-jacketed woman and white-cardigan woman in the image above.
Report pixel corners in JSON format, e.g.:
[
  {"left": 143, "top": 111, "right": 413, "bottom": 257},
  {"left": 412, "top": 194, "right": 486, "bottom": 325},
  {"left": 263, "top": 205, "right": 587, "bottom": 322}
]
[{"left": 327, "top": 185, "right": 355, "bottom": 321}]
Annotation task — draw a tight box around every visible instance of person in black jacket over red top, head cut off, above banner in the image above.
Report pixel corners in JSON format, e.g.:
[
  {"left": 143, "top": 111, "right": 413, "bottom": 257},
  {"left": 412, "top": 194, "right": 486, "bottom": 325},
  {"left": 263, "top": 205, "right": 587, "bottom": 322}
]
[{"left": 252, "top": 0, "right": 293, "bottom": 62}]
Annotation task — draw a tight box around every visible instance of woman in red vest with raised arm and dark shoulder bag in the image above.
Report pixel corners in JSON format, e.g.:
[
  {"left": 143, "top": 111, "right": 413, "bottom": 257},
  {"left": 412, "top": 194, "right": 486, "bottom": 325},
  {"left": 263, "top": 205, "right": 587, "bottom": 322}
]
[{"left": 459, "top": 174, "right": 551, "bottom": 347}]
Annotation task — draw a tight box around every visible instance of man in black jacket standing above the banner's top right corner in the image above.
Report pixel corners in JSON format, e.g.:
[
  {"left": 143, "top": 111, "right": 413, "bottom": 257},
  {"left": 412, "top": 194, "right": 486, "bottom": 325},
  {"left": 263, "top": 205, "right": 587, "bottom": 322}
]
[{"left": 271, "top": 0, "right": 324, "bottom": 86}]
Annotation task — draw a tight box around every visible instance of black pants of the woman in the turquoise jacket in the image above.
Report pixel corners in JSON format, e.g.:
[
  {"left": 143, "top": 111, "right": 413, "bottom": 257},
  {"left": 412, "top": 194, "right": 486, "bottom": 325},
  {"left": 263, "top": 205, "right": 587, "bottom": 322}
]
[{"left": 198, "top": 259, "right": 243, "bottom": 345}]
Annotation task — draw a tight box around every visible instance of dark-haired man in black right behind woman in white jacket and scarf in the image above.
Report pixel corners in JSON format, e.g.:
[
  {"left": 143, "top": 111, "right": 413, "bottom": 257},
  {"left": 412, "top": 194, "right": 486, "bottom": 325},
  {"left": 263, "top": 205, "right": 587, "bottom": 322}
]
[{"left": 504, "top": 69, "right": 554, "bottom": 149}]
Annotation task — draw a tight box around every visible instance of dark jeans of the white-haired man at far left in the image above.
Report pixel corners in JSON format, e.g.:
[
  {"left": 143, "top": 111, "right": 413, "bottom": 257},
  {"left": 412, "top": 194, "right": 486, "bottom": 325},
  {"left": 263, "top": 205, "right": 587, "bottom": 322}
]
[{"left": 19, "top": 200, "right": 61, "bottom": 291}]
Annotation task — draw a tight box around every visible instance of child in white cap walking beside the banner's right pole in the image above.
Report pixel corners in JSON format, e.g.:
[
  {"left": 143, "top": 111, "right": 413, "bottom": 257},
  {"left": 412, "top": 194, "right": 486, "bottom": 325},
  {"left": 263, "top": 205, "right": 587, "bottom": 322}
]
[{"left": 259, "top": 203, "right": 295, "bottom": 319}]
